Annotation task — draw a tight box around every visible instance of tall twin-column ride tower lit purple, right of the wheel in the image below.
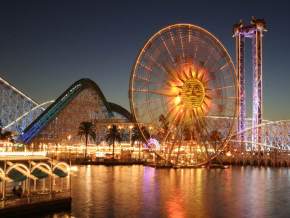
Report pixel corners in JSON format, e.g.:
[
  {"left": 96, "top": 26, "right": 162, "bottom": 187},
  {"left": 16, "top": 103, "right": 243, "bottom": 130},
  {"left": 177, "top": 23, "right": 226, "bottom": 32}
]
[{"left": 234, "top": 17, "right": 266, "bottom": 150}]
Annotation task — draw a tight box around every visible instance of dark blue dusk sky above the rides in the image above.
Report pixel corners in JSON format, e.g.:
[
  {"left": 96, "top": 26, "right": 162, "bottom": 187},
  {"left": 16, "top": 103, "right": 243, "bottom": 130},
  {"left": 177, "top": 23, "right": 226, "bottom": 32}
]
[{"left": 0, "top": 0, "right": 290, "bottom": 120}]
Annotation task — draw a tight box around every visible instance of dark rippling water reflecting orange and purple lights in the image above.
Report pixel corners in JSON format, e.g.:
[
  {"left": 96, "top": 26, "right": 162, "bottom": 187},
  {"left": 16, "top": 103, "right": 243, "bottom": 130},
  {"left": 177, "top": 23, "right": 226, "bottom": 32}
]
[{"left": 49, "top": 166, "right": 290, "bottom": 218}]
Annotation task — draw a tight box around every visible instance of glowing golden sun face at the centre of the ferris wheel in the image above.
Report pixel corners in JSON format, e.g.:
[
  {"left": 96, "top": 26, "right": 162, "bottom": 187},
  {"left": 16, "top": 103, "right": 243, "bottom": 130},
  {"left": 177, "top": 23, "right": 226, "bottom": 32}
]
[{"left": 166, "top": 63, "right": 212, "bottom": 123}]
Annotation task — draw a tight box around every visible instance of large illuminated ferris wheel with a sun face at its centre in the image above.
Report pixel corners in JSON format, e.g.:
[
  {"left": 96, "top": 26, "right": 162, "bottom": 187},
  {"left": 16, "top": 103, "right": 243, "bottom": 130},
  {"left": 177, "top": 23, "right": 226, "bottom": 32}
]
[{"left": 129, "top": 24, "right": 238, "bottom": 165}]
